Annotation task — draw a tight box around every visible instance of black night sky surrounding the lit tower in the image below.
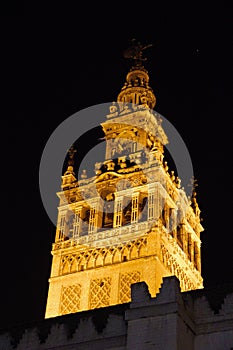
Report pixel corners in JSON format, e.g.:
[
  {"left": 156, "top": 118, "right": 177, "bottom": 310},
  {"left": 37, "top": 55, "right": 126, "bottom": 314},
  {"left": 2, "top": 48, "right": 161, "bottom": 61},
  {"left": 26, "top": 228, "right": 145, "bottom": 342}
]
[{"left": 0, "top": 1, "right": 233, "bottom": 328}]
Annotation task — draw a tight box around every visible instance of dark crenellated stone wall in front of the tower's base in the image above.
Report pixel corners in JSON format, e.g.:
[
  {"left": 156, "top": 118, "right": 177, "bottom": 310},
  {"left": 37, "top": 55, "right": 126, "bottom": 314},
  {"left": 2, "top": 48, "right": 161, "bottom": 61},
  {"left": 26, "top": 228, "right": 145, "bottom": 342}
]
[{"left": 0, "top": 273, "right": 233, "bottom": 350}]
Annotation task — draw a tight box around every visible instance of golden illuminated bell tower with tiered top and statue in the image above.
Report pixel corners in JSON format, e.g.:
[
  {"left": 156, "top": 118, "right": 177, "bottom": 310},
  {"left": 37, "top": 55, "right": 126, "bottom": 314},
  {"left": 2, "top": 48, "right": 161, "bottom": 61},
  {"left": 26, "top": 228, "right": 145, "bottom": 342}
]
[{"left": 45, "top": 43, "right": 203, "bottom": 318}]
